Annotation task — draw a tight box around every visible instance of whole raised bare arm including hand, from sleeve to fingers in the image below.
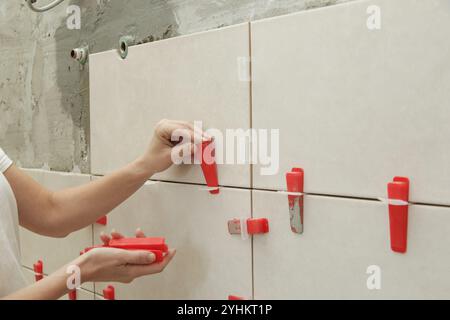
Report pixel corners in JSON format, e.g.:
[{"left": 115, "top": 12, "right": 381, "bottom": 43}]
[{"left": 5, "top": 120, "right": 196, "bottom": 237}]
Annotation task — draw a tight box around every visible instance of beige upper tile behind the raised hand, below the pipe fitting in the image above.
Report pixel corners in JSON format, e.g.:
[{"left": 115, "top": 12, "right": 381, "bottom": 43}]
[{"left": 89, "top": 24, "right": 250, "bottom": 188}]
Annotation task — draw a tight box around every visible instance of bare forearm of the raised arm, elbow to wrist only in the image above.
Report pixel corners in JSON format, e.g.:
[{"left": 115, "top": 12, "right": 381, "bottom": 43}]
[{"left": 51, "top": 159, "right": 154, "bottom": 235}]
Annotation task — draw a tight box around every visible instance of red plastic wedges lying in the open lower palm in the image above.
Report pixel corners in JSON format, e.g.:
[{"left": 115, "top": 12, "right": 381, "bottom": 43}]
[{"left": 82, "top": 238, "right": 169, "bottom": 262}]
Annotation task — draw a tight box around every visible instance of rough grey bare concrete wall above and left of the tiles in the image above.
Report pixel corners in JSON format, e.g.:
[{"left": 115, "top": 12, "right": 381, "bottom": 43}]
[{"left": 0, "top": 0, "right": 352, "bottom": 172}]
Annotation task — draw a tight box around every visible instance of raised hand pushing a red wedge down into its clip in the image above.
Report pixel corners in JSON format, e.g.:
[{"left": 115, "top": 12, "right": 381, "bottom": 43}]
[{"left": 142, "top": 120, "right": 211, "bottom": 173}]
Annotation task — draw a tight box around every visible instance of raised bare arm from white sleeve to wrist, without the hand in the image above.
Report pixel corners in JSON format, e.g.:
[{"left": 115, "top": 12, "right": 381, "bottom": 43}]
[{"left": 5, "top": 158, "right": 155, "bottom": 237}]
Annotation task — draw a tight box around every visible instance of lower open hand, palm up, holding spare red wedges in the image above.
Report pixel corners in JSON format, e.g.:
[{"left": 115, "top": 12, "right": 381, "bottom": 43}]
[{"left": 75, "top": 229, "right": 176, "bottom": 283}]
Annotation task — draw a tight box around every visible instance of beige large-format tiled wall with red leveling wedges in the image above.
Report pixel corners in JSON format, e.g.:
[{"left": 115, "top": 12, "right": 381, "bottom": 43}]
[{"left": 22, "top": 0, "right": 450, "bottom": 299}]
